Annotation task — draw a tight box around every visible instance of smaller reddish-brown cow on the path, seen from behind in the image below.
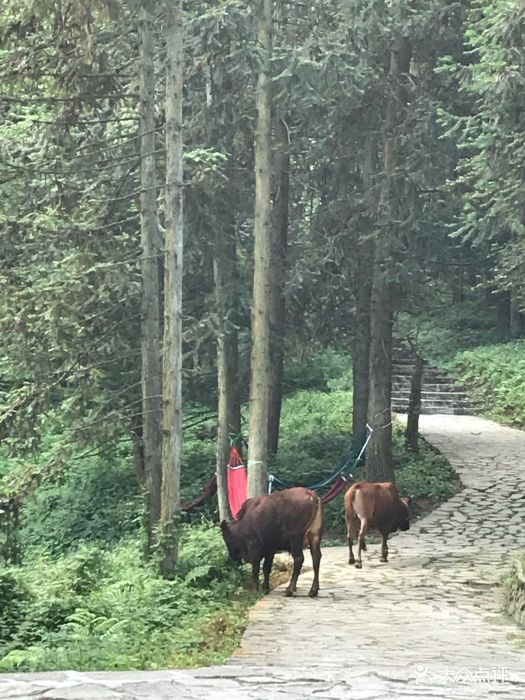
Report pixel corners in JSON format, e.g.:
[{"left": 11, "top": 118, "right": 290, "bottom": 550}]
[{"left": 345, "top": 481, "right": 411, "bottom": 569}]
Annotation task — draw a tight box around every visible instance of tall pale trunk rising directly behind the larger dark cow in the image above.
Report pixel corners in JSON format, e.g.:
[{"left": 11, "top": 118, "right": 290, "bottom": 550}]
[{"left": 248, "top": 0, "right": 272, "bottom": 496}]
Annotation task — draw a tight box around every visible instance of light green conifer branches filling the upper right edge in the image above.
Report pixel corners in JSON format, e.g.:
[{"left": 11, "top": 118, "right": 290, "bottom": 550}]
[{"left": 446, "top": 0, "right": 525, "bottom": 305}]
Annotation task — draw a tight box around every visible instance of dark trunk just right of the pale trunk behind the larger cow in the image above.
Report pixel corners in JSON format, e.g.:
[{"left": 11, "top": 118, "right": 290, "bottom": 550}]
[{"left": 268, "top": 117, "right": 290, "bottom": 454}]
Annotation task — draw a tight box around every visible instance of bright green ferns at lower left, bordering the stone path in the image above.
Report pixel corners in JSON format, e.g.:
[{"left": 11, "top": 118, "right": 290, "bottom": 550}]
[{"left": 0, "top": 522, "right": 253, "bottom": 670}]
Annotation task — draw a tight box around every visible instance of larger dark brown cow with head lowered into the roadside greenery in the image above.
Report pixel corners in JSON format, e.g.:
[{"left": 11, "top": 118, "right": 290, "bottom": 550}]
[{"left": 221, "top": 487, "right": 323, "bottom": 598}]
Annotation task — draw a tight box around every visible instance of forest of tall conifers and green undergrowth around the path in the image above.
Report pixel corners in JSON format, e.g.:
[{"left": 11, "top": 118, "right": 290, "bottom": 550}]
[{"left": 0, "top": 0, "right": 525, "bottom": 671}]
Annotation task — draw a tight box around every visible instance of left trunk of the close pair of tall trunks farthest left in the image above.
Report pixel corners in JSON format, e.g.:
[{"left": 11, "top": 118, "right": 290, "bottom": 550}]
[{"left": 139, "top": 4, "right": 162, "bottom": 544}]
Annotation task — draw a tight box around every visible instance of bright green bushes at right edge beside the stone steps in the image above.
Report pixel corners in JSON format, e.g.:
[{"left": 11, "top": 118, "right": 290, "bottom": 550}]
[{"left": 450, "top": 340, "right": 525, "bottom": 428}]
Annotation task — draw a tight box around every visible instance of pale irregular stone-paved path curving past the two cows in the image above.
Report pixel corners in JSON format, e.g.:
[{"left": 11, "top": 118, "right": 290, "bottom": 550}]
[{"left": 0, "top": 416, "right": 525, "bottom": 700}]
